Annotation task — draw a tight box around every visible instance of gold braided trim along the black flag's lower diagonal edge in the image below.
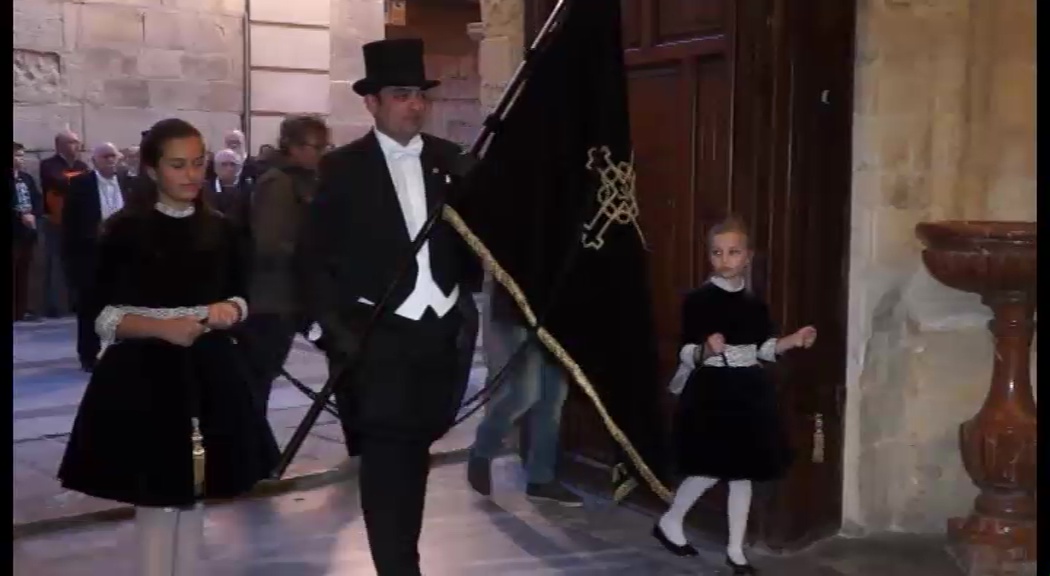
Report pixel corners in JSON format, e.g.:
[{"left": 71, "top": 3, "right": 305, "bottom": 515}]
[{"left": 441, "top": 206, "right": 673, "bottom": 503}]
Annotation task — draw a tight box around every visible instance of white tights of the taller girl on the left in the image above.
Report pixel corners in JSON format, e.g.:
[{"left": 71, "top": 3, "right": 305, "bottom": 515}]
[{"left": 134, "top": 504, "right": 204, "bottom": 576}]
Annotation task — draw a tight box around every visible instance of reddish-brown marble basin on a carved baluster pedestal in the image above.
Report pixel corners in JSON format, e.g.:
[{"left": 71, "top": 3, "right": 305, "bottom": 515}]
[{"left": 916, "top": 221, "right": 1036, "bottom": 576}]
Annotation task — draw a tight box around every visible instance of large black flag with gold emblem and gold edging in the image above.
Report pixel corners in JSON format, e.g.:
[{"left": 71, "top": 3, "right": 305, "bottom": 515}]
[{"left": 442, "top": 0, "right": 670, "bottom": 499}]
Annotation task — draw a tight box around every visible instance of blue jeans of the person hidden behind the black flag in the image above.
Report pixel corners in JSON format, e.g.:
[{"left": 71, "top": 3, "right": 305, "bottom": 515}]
[{"left": 470, "top": 322, "right": 569, "bottom": 484}]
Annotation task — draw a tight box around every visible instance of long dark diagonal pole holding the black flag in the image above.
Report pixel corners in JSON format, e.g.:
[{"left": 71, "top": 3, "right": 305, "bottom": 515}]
[{"left": 273, "top": 0, "right": 571, "bottom": 478}]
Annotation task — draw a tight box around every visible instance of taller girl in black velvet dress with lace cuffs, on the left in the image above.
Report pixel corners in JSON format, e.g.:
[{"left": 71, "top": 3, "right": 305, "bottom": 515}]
[{"left": 59, "top": 119, "right": 278, "bottom": 576}]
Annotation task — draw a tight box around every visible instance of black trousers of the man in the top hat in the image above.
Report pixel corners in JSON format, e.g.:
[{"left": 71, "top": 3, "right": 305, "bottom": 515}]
[{"left": 333, "top": 311, "right": 473, "bottom": 576}]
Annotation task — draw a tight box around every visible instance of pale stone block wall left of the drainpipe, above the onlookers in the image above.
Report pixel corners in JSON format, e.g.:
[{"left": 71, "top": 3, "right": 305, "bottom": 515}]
[{"left": 14, "top": 0, "right": 245, "bottom": 172}]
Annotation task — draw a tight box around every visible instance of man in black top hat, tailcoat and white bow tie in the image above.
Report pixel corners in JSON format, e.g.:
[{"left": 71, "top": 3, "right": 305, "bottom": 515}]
[{"left": 298, "top": 39, "right": 481, "bottom": 576}]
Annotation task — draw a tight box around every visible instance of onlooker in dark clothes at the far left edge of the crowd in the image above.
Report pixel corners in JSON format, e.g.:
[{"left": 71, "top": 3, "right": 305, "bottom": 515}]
[{"left": 11, "top": 142, "right": 44, "bottom": 322}]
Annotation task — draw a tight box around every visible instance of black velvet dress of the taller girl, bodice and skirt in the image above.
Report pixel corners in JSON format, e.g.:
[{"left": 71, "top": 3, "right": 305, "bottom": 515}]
[{"left": 59, "top": 206, "right": 278, "bottom": 507}]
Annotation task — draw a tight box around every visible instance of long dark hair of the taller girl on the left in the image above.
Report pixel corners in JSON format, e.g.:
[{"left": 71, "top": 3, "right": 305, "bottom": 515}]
[{"left": 109, "top": 118, "right": 217, "bottom": 246}]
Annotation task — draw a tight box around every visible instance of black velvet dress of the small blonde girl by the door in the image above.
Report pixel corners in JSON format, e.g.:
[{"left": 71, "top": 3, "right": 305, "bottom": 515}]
[{"left": 675, "top": 282, "right": 792, "bottom": 481}]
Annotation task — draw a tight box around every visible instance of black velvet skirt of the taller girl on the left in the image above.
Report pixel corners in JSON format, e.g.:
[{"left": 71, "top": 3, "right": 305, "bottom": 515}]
[{"left": 59, "top": 332, "right": 279, "bottom": 507}]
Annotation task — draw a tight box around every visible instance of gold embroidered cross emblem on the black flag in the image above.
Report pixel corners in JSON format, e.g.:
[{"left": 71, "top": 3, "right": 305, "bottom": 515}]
[{"left": 583, "top": 146, "right": 648, "bottom": 250}]
